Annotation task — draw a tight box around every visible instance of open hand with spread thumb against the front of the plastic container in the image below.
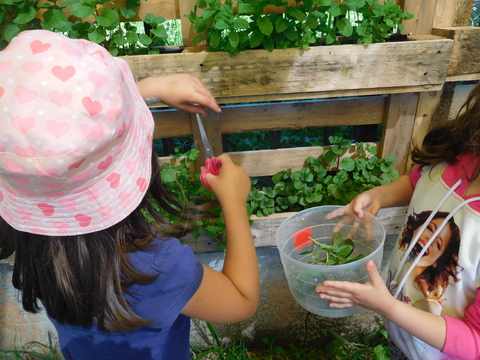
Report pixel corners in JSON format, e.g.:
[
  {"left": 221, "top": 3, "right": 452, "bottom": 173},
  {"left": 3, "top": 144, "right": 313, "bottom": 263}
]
[{"left": 315, "top": 260, "right": 396, "bottom": 315}]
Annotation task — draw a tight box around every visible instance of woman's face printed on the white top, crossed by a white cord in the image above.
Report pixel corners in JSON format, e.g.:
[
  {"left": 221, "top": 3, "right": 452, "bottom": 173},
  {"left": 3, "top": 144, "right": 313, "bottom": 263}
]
[{"left": 413, "top": 219, "right": 452, "bottom": 267}]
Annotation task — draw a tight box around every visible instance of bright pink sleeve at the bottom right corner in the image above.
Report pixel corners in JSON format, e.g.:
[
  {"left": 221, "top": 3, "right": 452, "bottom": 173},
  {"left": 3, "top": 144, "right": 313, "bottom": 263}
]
[{"left": 442, "top": 291, "right": 480, "bottom": 360}]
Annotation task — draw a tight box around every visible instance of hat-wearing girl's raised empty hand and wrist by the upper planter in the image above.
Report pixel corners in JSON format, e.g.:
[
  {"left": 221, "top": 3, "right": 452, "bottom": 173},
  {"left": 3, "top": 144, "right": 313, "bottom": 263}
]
[{"left": 137, "top": 74, "right": 221, "bottom": 115}]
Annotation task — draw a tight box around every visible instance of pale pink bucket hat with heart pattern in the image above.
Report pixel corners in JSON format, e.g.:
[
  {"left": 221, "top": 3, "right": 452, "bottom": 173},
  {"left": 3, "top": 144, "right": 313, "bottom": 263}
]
[{"left": 0, "top": 30, "right": 154, "bottom": 236}]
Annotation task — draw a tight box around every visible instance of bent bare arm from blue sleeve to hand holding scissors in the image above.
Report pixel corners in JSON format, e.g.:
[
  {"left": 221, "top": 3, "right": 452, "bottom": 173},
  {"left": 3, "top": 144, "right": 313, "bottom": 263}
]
[{"left": 182, "top": 154, "right": 260, "bottom": 323}]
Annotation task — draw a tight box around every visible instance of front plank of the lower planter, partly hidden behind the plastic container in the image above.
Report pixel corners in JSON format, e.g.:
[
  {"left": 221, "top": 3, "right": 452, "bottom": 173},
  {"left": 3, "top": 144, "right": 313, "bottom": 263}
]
[{"left": 182, "top": 206, "right": 408, "bottom": 253}]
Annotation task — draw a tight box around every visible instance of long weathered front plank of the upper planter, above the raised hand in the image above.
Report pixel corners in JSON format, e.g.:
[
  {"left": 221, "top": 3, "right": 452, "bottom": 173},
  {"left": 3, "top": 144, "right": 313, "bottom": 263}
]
[{"left": 123, "top": 39, "right": 453, "bottom": 98}]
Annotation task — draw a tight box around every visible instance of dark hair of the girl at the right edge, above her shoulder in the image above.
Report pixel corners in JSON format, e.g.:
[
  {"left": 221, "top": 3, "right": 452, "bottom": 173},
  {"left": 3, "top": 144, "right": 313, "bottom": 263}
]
[{"left": 412, "top": 83, "right": 480, "bottom": 181}]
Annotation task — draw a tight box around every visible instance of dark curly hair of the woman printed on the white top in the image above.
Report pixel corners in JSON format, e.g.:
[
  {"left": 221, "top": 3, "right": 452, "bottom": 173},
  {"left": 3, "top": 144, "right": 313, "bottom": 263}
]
[{"left": 399, "top": 211, "right": 461, "bottom": 298}]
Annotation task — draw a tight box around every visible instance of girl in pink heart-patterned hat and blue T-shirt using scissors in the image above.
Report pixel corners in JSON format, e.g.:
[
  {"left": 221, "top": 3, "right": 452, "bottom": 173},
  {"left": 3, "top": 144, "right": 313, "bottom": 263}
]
[{"left": 0, "top": 30, "right": 259, "bottom": 360}]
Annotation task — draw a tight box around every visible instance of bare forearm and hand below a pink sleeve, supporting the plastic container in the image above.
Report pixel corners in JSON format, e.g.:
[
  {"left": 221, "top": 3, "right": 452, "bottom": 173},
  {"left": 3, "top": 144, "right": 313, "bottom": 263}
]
[{"left": 316, "top": 260, "right": 447, "bottom": 350}]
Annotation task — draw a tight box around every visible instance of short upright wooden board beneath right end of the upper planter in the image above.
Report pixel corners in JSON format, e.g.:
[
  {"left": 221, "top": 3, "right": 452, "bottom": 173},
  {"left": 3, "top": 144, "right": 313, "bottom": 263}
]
[{"left": 379, "top": 93, "right": 419, "bottom": 175}]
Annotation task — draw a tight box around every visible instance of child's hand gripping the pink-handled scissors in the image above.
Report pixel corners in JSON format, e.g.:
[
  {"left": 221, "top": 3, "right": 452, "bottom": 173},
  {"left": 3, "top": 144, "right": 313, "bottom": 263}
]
[{"left": 205, "top": 154, "right": 251, "bottom": 208}]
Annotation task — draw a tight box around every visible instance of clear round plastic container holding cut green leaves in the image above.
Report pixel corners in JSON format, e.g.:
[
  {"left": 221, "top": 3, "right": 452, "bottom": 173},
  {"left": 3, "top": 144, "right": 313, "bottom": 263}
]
[{"left": 276, "top": 206, "right": 385, "bottom": 318}]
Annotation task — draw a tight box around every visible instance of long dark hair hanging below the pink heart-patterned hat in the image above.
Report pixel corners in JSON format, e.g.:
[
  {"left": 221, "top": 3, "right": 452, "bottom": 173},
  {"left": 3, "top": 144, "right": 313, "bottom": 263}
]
[{"left": 0, "top": 148, "right": 218, "bottom": 331}]
